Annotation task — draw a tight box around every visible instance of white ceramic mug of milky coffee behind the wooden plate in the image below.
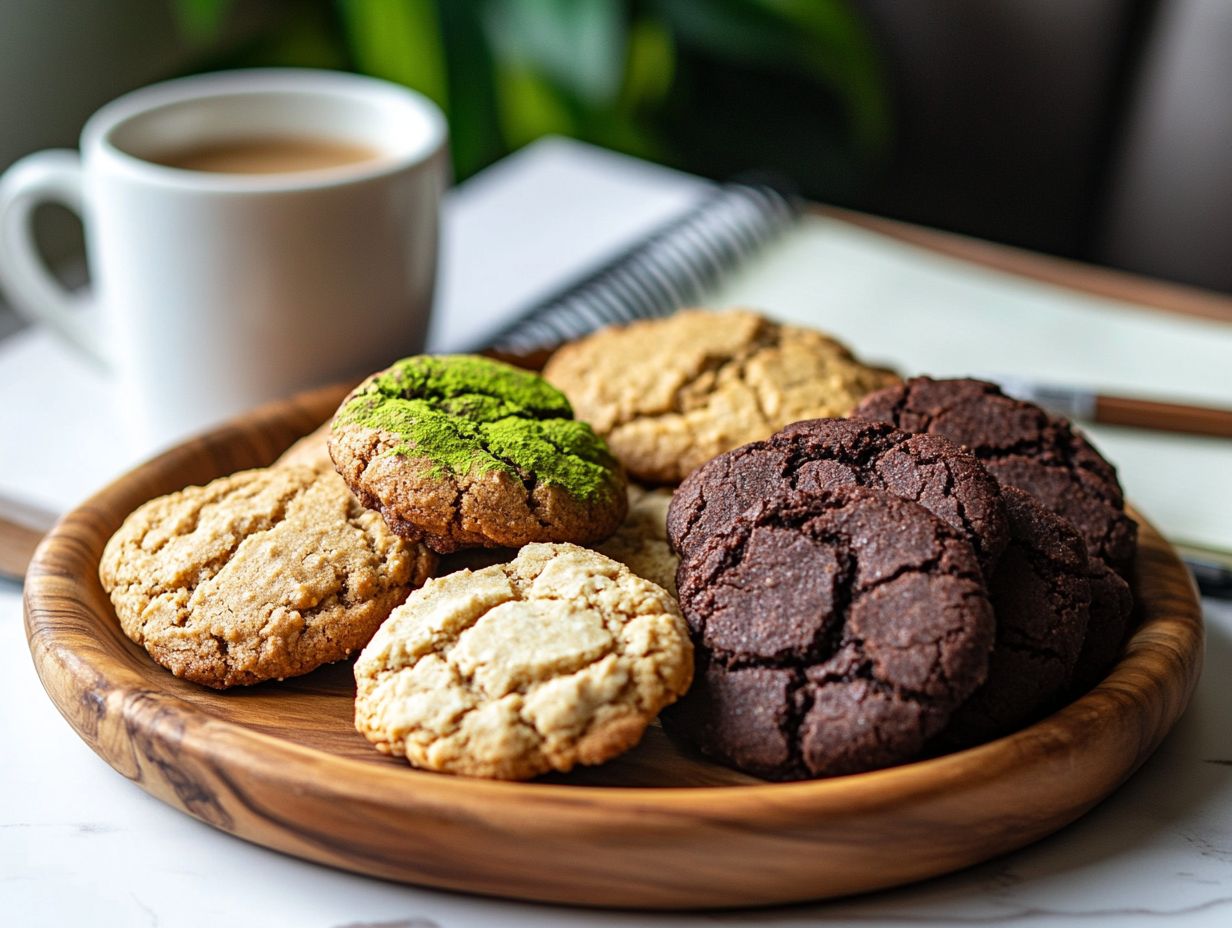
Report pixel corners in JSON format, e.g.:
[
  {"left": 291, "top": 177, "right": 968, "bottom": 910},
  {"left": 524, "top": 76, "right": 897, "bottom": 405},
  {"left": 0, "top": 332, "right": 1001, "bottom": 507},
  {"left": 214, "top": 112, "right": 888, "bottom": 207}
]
[{"left": 0, "top": 69, "right": 448, "bottom": 440}]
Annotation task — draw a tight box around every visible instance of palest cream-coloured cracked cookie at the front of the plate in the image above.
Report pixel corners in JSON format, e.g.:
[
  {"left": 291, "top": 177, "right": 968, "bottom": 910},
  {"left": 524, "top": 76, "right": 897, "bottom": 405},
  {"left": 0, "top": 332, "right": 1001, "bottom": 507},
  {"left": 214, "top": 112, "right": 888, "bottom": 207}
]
[{"left": 355, "top": 545, "right": 692, "bottom": 780}]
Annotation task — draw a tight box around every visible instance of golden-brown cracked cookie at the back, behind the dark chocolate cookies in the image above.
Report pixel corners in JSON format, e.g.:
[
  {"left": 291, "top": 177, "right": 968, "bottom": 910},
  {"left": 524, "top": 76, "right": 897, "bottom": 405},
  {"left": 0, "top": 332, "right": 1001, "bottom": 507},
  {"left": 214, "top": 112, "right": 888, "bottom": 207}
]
[{"left": 543, "top": 309, "right": 898, "bottom": 486}]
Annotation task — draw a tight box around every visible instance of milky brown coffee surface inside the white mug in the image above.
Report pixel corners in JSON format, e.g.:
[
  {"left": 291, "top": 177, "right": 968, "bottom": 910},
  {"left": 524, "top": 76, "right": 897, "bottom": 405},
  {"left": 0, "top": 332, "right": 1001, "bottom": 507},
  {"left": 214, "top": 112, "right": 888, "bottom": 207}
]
[{"left": 149, "top": 136, "right": 381, "bottom": 174}]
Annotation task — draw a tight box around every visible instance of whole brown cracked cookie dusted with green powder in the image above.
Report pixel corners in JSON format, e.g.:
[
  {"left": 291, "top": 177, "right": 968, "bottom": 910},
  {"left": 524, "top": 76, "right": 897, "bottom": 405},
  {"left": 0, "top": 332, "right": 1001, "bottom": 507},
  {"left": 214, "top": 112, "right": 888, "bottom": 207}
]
[{"left": 329, "top": 355, "right": 627, "bottom": 553}]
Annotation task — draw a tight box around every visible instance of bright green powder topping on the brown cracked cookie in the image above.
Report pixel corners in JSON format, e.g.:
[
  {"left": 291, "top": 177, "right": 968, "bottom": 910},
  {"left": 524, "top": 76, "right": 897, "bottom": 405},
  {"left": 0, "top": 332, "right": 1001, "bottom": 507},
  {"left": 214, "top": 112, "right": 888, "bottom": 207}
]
[{"left": 338, "top": 355, "right": 616, "bottom": 500}]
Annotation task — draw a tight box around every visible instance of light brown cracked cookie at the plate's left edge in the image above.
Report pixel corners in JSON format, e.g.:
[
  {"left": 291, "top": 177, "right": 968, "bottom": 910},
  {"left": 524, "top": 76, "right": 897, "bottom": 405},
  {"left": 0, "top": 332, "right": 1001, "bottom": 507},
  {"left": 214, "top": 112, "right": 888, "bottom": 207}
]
[{"left": 99, "top": 466, "right": 435, "bottom": 689}]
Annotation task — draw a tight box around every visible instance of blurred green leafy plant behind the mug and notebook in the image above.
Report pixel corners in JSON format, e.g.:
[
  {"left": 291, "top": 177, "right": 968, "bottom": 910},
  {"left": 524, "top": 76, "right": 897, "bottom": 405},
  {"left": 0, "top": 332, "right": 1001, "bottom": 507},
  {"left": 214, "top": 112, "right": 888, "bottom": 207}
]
[{"left": 172, "top": 0, "right": 891, "bottom": 198}]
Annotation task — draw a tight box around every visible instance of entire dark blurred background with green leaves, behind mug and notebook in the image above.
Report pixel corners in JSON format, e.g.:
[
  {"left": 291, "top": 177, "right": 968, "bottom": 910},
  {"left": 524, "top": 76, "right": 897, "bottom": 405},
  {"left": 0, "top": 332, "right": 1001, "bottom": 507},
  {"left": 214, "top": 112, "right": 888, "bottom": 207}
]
[{"left": 0, "top": 0, "right": 1232, "bottom": 315}]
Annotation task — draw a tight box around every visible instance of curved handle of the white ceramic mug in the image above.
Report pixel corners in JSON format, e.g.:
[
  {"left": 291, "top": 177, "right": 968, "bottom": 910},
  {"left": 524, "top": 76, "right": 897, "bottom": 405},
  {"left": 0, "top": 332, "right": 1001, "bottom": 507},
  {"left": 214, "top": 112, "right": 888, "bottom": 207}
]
[{"left": 0, "top": 149, "right": 111, "bottom": 368}]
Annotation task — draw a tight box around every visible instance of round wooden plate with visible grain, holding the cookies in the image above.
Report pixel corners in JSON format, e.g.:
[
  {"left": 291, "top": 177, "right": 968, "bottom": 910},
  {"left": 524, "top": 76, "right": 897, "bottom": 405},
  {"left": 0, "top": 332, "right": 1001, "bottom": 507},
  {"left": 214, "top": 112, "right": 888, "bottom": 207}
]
[{"left": 26, "top": 379, "right": 1202, "bottom": 907}]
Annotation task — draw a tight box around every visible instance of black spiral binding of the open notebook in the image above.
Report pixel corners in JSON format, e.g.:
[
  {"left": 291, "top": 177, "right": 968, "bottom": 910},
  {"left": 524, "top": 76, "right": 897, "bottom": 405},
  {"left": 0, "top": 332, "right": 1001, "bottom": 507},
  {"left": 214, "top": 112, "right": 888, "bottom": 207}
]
[{"left": 488, "top": 184, "right": 800, "bottom": 354}]
